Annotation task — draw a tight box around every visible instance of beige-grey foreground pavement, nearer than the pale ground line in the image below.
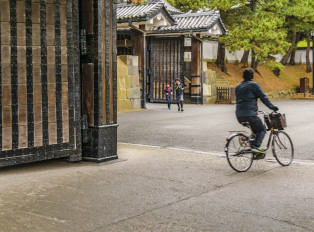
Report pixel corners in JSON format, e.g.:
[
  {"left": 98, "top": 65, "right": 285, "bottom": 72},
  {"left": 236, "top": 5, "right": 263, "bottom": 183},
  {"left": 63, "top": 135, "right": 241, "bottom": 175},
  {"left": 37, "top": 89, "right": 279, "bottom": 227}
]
[{"left": 0, "top": 144, "right": 314, "bottom": 232}]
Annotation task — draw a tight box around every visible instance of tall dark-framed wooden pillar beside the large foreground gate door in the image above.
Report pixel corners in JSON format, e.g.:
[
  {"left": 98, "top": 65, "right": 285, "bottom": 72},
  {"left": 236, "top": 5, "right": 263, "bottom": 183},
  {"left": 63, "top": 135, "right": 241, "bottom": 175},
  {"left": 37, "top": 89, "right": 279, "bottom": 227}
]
[{"left": 80, "top": 0, "right": 118, "bottom": 162}]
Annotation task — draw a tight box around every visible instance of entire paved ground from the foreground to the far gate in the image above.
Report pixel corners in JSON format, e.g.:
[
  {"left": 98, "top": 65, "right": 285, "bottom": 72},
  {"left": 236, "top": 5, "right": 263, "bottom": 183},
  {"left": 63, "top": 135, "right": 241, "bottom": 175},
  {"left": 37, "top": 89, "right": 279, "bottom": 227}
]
[{"left": 0, "top": 101, "right": 314, "bottom": 232}]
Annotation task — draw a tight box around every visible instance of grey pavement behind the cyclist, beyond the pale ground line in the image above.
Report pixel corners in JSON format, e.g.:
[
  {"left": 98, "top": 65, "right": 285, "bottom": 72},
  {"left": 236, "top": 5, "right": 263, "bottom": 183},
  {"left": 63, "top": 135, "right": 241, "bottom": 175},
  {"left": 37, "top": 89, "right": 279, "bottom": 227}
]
[{"left": 118, "top": 100, "right": 314, "bottom": 160}]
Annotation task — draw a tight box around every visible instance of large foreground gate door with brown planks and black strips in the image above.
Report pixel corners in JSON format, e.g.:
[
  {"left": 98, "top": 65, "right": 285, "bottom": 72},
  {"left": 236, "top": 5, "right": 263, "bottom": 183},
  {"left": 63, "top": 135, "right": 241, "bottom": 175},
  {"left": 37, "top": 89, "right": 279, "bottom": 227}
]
[{"left": 0, "top": 0, "right": 81, "bottom": 167}]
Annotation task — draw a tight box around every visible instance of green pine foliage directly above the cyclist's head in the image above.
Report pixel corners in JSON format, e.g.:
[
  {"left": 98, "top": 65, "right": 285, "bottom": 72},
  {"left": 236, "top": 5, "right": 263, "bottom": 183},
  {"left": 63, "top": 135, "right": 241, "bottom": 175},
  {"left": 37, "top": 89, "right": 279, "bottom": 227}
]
[{"left": 211, "top": 0, "right": 289, "bottom": 70}]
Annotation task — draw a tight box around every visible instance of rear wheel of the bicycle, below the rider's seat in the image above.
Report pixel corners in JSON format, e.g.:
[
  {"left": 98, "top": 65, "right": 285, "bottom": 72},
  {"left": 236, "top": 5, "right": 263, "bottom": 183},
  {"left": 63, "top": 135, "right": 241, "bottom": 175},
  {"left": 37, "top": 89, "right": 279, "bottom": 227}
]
[{"left": 225, "top": 134, "right": 253, "bottom": 172}]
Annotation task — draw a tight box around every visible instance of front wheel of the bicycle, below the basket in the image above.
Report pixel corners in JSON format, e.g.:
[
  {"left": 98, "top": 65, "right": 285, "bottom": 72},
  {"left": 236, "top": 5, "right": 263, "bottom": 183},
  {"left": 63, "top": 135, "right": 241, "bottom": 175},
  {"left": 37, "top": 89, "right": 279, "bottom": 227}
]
[{"left": 272, "top": 131, "right": 294, "bottom": 166}]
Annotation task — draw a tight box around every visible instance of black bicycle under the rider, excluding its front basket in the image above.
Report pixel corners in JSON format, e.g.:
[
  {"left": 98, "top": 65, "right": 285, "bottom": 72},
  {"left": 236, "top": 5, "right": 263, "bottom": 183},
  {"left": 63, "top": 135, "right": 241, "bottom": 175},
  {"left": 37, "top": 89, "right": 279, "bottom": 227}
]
[{"left": 225, "top": 111, "right": 294, "bottom": 172}]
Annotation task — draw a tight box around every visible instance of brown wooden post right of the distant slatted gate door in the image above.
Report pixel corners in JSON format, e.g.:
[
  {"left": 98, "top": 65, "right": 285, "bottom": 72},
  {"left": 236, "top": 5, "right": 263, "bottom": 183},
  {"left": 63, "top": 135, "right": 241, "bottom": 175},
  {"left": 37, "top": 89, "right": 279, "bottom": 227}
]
[{"left": 191, "top": 37, "right": 201, "bottom": 104}]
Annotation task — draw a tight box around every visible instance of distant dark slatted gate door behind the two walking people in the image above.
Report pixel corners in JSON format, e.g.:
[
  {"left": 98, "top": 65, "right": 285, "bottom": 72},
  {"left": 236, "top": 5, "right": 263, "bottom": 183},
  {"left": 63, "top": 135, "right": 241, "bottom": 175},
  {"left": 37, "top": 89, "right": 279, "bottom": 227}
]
[{"left": 148, "top": 37, "right": 184, "bottom": 102}]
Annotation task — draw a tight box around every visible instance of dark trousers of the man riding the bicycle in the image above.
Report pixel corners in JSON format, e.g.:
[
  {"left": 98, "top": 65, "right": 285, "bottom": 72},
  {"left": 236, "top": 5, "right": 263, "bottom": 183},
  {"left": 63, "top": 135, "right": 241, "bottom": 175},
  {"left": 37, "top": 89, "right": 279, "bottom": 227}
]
[{"left": 237, "top": 116, "right": 266, "bottom": 147}]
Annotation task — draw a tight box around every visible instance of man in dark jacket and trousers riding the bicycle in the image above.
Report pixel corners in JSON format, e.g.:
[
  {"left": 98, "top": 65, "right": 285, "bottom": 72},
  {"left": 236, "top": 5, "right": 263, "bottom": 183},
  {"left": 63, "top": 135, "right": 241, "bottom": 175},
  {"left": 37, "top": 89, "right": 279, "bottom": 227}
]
[{"left": 235, "top": 68, "right": 278, "bottom": 154}]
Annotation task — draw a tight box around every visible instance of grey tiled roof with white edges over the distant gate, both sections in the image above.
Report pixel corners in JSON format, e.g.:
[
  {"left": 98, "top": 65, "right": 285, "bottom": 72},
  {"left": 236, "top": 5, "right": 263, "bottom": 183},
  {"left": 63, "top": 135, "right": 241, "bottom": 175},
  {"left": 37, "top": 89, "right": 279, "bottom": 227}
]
[{"left": 117, "top": 0, "right": 227, "bottom": 34}]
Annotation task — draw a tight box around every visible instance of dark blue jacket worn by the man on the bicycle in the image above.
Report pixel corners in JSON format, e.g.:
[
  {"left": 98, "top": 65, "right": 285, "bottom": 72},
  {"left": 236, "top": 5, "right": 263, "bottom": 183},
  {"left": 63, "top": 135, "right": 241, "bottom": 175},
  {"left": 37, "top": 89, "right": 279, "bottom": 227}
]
[{"left": 236, "top": 80, "right": 275, "bottom": 117}]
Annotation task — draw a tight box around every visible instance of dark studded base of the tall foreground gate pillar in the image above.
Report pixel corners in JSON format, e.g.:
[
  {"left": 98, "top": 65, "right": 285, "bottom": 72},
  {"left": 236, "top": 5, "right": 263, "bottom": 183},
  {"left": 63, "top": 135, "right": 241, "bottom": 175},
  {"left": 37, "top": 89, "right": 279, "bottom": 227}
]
[{"left": 83, "top": 124, "right": 118, "bottom": 163}]
